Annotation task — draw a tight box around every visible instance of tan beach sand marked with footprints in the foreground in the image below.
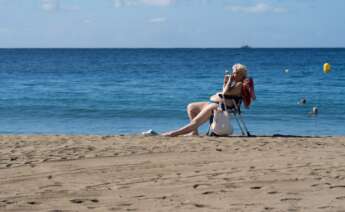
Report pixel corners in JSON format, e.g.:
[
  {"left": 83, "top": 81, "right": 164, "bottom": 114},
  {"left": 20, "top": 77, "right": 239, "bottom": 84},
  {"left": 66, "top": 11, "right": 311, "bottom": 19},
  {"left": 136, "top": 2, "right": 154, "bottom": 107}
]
[{"left": 0, "top": 136, "right": 345, "bottom": 212}]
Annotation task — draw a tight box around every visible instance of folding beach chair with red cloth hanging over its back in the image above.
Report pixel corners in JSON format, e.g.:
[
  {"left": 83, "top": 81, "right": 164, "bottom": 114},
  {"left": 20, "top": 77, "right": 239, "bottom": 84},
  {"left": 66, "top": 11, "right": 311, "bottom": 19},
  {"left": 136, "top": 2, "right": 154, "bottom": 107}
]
[{"left": 207, "top": 78, "right": 256, "bottom": 137}]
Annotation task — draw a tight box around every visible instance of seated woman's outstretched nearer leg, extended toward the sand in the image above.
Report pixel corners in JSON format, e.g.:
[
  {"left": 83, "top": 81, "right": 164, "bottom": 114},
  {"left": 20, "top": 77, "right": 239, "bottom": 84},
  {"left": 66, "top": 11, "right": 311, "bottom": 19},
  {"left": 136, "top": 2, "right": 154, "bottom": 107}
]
[{"left": 163, "top": 103, "right": 218, "bottom": 137}]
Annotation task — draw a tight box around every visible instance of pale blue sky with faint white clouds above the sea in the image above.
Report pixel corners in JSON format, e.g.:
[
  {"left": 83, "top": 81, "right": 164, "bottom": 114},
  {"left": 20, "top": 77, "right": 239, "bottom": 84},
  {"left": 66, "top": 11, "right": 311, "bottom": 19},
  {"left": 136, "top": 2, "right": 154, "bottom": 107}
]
[{"left": 0, "top": 0, "right": 345, "bottom": 48}]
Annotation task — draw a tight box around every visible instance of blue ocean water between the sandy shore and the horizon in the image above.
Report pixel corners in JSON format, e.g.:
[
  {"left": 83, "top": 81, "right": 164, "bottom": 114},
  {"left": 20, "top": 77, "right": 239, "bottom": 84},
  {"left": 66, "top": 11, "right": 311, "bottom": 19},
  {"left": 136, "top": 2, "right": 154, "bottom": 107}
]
[{"left": 0, "top": 48, "right": 345, "bottom": 135}]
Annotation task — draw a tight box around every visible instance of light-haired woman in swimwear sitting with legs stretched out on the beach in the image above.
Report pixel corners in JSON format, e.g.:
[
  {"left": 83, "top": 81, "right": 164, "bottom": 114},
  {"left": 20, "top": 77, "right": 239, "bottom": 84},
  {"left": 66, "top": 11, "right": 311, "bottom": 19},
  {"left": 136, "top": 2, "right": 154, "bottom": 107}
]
[{"left": 162, "top": 64, "right": 247, "bottom": 137}]
